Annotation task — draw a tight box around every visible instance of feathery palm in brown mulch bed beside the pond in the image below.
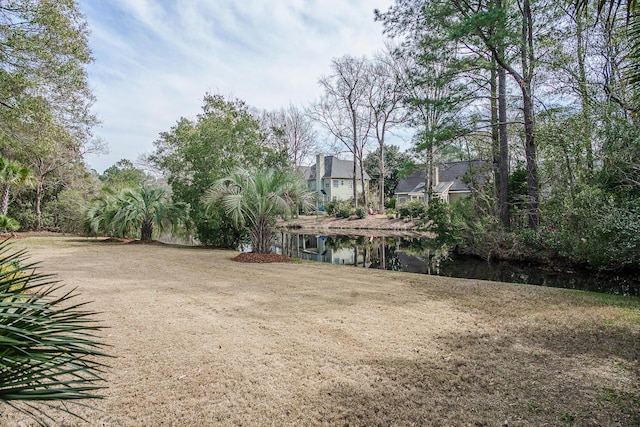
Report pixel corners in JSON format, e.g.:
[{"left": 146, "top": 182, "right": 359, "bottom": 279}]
[{"left": 204, "top": 168, "right": 314, "bottom": 254}]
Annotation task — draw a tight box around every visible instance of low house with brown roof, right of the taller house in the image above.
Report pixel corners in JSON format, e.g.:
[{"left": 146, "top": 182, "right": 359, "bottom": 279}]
[{"left": 395, "top": 160, "right": 490, "bottom": 204}]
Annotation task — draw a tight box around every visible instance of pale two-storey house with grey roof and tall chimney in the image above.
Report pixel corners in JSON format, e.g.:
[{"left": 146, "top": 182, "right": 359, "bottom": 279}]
[{"left": 305, "top": 154, "right": 370, "bottom": 206}]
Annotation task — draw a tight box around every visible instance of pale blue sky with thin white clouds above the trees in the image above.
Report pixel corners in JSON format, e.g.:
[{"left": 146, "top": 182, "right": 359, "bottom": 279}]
[{"left": 78, "top": 0, "right": 391, "bottom": 173}]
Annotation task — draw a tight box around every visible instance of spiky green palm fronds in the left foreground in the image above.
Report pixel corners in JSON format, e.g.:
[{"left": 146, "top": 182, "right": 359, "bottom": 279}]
[{"left": 0, "top": 241, "right": 107, "bottom": 425}]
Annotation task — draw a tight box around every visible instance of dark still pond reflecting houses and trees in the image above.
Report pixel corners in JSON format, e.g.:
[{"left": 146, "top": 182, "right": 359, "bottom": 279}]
[{"left": 275, "top": 232, "right": 640, "bottom": 295}]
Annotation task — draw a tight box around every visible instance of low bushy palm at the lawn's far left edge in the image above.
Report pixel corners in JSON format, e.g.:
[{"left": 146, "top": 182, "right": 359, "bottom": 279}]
[{"left": 85, "top": 186, "right": 188, "bottom": 241}]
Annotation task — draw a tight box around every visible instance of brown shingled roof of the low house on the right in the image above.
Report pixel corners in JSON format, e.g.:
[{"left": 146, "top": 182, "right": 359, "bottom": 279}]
[{"left": 396, "top": 160, "right": 488, "bottom": 194}]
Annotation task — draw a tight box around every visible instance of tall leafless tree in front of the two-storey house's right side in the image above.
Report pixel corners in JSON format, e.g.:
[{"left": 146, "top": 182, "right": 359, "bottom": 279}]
[{"left": 311, "top": 55, "right": 373, "bottom": 207}]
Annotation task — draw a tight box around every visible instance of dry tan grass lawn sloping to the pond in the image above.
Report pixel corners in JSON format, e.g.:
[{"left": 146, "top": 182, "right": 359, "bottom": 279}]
[{"left": 0, "top": 237, "right": 640, "bottom": 426}]
